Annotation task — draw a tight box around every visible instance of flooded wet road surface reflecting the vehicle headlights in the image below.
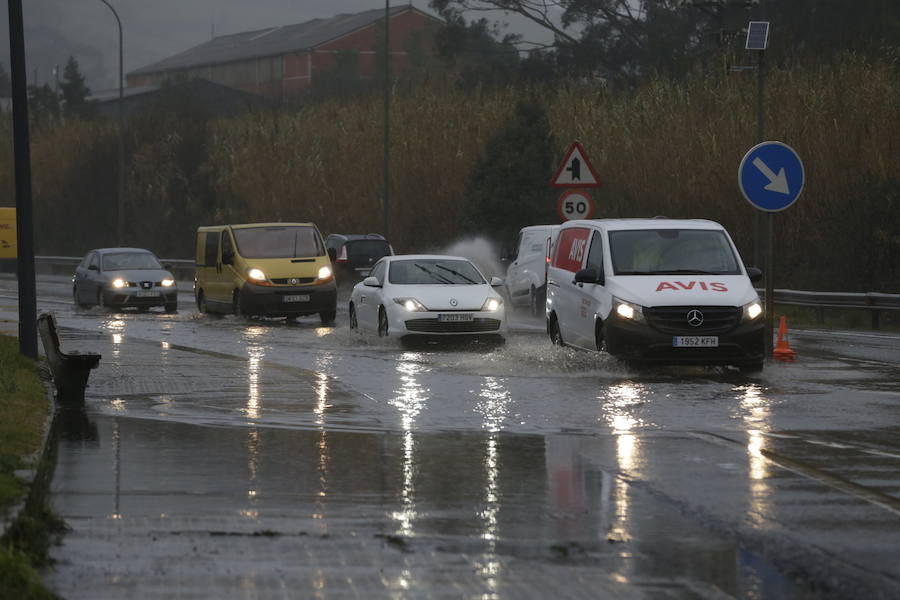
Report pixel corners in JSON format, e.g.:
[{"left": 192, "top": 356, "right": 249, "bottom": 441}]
[{"left": 0, "top": 280, "right": 900, "bottom": 598}]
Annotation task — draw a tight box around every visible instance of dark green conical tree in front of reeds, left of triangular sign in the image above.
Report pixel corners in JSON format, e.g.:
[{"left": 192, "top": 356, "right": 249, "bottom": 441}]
[{"left": 460, "top": 100, "right": 557, "bottom": 243}]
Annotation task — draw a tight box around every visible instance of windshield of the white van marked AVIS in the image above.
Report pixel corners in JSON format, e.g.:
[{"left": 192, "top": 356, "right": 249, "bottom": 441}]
[{"left": 609, "top": 229, "right": 741, "bottom": 275}]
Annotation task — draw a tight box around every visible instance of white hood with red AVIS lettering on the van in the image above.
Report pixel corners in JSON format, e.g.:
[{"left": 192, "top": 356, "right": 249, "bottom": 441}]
[{"left": 606, "top": 275, "right": 758, "bottom": 307}]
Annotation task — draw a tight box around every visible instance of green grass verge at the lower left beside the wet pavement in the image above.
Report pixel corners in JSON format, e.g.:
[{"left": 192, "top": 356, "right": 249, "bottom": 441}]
[{"left": 0, "top": 335, "right": 64, "bottom": 600}]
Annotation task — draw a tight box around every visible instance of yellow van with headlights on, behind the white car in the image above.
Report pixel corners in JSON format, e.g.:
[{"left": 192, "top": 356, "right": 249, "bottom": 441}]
[{"left": 194, "top": 223, "right": 337, "bottom": 323}]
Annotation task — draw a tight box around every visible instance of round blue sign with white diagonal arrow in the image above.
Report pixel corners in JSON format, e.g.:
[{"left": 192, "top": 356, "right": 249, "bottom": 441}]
[{"left": 738, "top": 142, "right": 806, "bottom": 212}]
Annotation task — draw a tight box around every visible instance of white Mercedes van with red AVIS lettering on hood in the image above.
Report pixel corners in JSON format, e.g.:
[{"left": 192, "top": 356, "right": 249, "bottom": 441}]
[{"left": 546, "top": 219, "right": 765, "bottom": 371}]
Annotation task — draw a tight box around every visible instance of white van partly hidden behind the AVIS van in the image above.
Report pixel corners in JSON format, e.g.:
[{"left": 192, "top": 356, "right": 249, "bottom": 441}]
[{"left": 506, "top": 225, "right": 560, "bottom": 317}]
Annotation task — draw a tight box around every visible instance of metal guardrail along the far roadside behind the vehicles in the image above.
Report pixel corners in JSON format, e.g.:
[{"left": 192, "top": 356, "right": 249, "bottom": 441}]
[{"left": 8, "top": 256, "right": 900, "bottom": 329}]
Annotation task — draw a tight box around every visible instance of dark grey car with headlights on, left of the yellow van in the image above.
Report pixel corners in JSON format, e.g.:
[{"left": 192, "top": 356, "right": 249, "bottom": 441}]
[{"left": 72, "top": 248, "right": 178, "bottom": 312}]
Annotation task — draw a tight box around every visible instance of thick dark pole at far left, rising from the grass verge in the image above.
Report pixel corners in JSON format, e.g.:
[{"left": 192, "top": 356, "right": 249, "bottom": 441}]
[{"left": 9, "top": 0, "right": 37, "bottom": 359}]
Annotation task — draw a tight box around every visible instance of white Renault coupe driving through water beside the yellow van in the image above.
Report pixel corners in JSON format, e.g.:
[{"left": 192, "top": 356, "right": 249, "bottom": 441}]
[{"left": 349, "top": 254, "right": 506, "bottom": 339}]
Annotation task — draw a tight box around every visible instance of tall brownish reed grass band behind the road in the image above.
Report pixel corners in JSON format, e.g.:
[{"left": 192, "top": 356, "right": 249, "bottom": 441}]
[{"left": 0, "top": 53, "right": 900, "bottom": 292}]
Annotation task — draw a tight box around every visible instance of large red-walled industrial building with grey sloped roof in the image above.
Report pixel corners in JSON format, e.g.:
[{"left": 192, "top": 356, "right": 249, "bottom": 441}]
[{"left": 127, "top": 6, "right": 442, "bottom": 100}]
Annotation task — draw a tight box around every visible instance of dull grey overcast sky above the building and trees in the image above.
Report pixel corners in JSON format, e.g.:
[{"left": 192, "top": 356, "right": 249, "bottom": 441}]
[{"left": 0, "top": 0, "right": 543, "bottom": 91}]
